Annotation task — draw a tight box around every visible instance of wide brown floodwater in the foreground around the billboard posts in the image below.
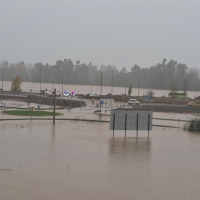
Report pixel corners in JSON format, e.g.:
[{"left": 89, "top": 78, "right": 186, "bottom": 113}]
[{"left": 0, "top": 114, "right": 200, "bottom": 200}]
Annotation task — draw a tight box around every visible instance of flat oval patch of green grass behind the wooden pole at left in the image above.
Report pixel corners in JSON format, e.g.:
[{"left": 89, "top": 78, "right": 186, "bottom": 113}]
[{"left": 2, "top": 110, "right": 62, "bottom": 116}]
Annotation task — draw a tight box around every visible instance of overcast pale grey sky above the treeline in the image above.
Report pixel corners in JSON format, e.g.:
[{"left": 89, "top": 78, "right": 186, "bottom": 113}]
[{"left": 0, "top": 0, "right": 200, "bottom": 70}]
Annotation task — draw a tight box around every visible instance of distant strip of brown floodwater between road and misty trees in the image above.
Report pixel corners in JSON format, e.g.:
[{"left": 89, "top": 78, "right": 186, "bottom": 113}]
[{"left": 4, "top": 81, "right": 200, "bottom": 98}]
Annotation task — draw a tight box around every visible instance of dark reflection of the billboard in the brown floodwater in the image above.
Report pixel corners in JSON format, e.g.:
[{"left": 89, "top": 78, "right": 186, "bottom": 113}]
[{"left": 109, "top": 138, "right": 151, "bottom": 167}]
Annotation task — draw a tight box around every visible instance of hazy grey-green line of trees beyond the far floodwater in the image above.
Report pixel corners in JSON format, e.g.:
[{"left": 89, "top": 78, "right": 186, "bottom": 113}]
[{"left": 0, "top": 59, "right": 200, "bottom": 91}]
